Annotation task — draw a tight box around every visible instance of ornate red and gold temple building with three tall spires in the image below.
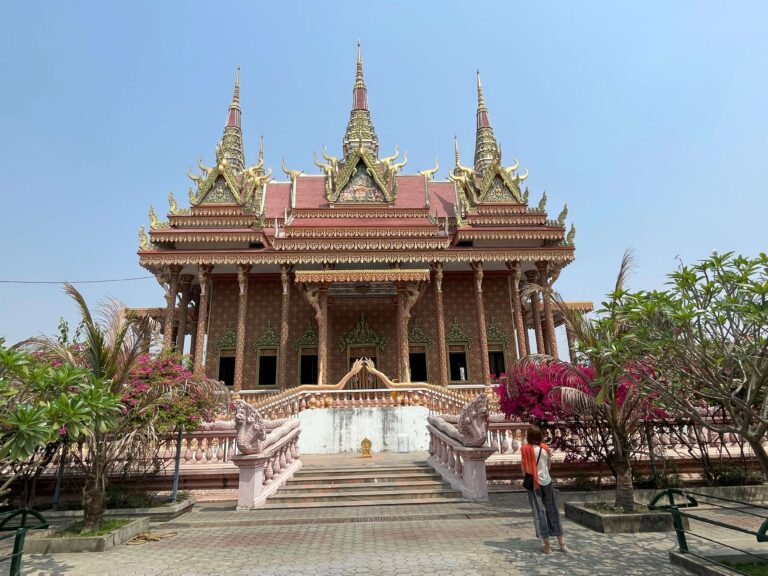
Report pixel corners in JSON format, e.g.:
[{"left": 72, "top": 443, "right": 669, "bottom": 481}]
[{"left": 135, "top": 47, "right": 591, "bottom": 390}]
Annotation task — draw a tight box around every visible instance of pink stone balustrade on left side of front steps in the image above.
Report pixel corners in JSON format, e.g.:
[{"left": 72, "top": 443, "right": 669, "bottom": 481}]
[{"left": 232, "top": 420, "right": 301, "bottom": 510}]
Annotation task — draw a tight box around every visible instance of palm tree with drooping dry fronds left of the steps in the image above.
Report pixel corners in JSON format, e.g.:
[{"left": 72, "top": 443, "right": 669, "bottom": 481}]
[{"left": 25, "top": 284, "right": 221, "bottom": 530}]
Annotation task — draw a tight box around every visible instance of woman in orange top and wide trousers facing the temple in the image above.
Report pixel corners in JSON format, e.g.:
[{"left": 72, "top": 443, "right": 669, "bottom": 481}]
[{"left": 521, "top": 426, "right": 568, "bottom": 554}]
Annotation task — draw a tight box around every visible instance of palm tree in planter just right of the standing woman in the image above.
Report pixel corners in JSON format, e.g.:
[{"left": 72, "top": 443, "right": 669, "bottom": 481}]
[{"left": 508, "top": 251, "right": 648, "bottom": 511}]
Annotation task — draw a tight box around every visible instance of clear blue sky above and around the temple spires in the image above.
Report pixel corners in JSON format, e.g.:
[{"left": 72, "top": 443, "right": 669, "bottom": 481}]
[{"left": 0, "top": 0, "right": 768, "bottom": 342}]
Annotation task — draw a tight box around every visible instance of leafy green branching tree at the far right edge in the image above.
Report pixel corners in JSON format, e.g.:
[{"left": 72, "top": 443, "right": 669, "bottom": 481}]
[{"left": 617, "top": 252, "right": 768, "bottom": 479}]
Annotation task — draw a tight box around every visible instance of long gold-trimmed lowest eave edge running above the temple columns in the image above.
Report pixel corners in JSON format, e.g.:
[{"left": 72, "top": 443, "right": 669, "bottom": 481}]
[{"left": 138, "top": 246, "right": 574, "bottom": 268}]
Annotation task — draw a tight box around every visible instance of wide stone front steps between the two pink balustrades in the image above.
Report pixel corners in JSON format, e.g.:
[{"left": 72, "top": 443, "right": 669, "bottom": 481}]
[{"left": 261, "top": 462, "right": 466, "bottom": 510}]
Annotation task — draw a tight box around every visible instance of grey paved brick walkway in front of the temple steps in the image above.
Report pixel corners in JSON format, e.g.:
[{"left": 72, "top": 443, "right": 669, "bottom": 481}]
[{"left": 22, "top": 494, "right": 686, "bottom": 576}]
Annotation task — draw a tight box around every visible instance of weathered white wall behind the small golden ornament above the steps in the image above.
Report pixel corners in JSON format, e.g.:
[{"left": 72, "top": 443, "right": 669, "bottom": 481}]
[{"left": 299, "top": 406, "right": 429, "bottom": 454}]
